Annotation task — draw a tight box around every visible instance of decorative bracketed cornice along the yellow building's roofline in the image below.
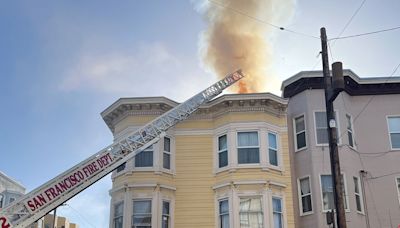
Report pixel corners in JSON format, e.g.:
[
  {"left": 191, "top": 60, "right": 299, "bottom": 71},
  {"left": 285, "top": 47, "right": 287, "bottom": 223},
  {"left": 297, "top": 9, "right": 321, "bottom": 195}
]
[{"left": 101, "top": 93, "right": 287, "bottom": 133}]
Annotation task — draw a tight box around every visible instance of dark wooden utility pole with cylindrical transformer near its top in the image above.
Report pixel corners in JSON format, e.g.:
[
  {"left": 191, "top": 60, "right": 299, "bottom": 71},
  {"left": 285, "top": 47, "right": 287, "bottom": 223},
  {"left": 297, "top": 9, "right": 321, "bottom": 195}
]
[{"left": 320, "top": 28, "right": 347, "bottom": 228}]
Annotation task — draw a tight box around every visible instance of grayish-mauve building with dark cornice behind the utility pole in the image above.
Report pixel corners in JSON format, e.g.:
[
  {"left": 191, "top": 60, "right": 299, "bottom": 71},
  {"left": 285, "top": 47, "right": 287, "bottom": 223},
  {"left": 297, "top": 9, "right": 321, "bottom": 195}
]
[{"left": 282, "top": 70, "right": 400, "bottom": 228}]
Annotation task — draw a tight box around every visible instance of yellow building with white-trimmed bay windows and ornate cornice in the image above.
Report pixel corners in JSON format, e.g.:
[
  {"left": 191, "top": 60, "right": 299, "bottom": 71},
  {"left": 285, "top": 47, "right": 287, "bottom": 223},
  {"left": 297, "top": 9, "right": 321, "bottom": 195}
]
[{"left": 102, "top": 93, "right": 294, "bottom": 228}]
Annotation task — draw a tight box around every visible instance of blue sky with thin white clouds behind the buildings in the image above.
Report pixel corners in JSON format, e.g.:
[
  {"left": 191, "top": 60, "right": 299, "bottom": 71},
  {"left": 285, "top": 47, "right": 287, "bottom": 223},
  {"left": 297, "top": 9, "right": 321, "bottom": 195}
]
[{"left": 0, "top": 0, "right": 400, "bottom": 228}]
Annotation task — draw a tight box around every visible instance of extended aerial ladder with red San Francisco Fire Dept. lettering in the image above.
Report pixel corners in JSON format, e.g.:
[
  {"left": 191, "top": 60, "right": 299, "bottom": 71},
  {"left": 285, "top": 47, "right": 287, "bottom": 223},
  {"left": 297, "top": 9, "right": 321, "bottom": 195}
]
[{"left": 0, "top": 70, "right": 244, "bottom": 228}]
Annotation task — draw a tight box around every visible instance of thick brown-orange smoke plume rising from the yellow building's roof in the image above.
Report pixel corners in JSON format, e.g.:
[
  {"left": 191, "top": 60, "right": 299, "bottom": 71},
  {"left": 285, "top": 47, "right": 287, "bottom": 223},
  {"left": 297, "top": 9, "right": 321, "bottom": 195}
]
[{"left": 200, "top": 0, "right": 294, "bottom": 93}]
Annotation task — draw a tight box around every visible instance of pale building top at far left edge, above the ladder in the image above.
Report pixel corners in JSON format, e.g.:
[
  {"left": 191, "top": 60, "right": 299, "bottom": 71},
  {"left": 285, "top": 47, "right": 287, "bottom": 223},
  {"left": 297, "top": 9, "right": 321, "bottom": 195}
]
[{"left": 0, "top": 172, "right": 25, "bottom": 209}]
